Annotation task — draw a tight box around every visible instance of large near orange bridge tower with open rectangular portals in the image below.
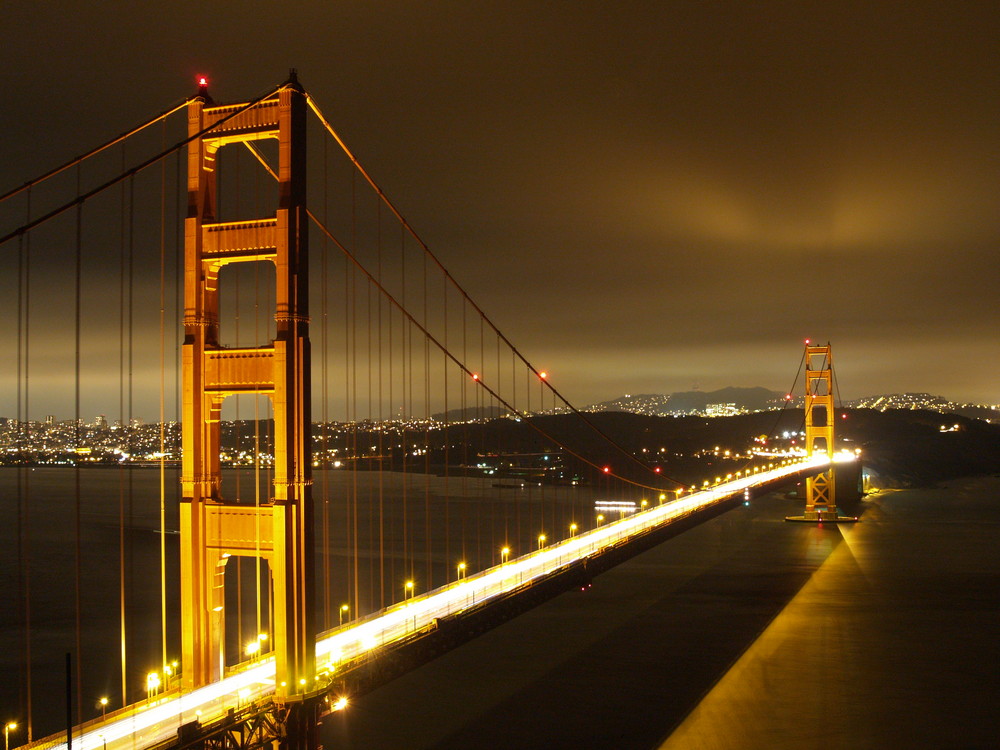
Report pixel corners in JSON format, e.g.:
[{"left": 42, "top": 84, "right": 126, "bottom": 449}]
[{"left": 180, "top": 75, "right": 315, "bottom": 712}]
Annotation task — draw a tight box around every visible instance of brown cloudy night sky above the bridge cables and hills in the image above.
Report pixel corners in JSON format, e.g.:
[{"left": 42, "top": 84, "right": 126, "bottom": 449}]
[{"left": 0, "top": 0, "right": 1000, "bottom": 418}]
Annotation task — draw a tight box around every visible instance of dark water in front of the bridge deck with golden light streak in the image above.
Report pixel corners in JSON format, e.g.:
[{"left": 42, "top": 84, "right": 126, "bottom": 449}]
[{"left": 323, "top": 479, "right": 1000, "bottom": 750}]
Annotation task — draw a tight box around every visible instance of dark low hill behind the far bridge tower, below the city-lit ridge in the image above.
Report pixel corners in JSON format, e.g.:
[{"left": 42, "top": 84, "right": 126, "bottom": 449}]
[{"left": 431, "top": 408, "right": 1000, "bottom": 487}]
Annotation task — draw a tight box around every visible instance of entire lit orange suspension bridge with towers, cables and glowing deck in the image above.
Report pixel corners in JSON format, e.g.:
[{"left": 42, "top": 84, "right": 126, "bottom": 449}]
[{"left": 0, "top": 74, "right": 857, "bottom": 748}]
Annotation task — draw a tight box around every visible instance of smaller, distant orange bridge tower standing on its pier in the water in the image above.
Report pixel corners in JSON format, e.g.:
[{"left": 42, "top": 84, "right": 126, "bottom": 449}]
[{"left": 785, "top": 341, "right": 858, "bottom": 523}]
